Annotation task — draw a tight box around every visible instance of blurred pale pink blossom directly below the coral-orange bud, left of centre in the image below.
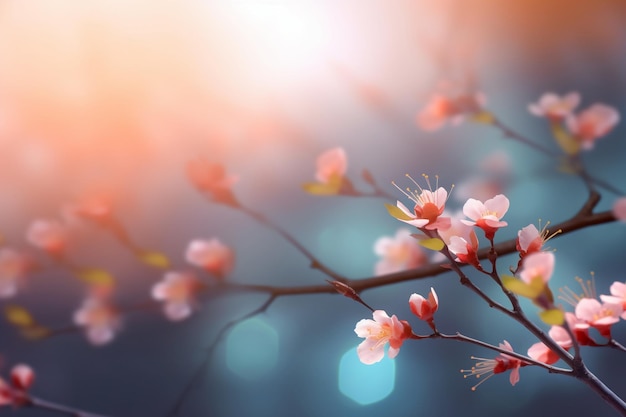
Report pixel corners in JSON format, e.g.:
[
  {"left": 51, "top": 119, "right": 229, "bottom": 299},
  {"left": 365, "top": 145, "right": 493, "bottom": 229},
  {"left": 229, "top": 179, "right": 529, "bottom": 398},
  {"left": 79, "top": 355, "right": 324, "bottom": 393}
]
[{"left": 185, "top": 238, "right": 235, "bottom": 278}]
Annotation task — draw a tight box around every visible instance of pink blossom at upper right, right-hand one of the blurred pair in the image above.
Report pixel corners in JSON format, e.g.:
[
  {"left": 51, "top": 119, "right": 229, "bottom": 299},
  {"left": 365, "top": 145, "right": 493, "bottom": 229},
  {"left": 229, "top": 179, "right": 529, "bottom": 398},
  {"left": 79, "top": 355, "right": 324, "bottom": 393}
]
[{"left": 565, "top": 103, "right": 620, "bottom": 150}]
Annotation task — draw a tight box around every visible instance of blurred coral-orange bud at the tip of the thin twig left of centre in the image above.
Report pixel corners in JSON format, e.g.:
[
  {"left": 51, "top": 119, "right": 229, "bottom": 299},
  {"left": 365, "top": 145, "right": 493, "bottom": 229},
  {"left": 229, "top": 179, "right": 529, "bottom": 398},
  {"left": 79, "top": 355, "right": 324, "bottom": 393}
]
[{"left": 187, "top": 158, "right": 239, "bottom": 206}]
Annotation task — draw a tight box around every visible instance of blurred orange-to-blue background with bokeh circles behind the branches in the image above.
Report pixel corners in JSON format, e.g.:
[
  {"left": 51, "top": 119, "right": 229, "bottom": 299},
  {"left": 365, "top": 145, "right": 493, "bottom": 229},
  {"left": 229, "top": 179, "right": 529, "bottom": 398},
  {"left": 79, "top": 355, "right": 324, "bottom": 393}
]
[{"left": 0, "top": 0, "right": 626, "bottom": 417}]
